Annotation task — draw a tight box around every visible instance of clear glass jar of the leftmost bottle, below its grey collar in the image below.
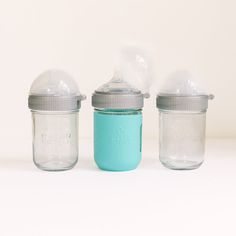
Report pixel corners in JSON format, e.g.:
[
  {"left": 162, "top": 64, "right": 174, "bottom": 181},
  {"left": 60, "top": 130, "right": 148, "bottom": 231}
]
[{"left": 32, "top": 111, "right": 78, "bottom": 171}]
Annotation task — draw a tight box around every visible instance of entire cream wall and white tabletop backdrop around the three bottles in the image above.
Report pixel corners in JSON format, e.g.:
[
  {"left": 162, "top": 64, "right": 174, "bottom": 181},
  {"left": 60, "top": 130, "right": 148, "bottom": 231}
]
[{"left": 0, "top": 0, "right": 236, "bottom": 236}]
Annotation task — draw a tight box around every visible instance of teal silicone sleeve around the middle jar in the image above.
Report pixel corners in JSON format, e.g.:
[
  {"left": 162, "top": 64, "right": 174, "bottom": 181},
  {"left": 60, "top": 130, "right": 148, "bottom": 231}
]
[{"left": 94, "top": 111, "right": 142, "bottom": 171}]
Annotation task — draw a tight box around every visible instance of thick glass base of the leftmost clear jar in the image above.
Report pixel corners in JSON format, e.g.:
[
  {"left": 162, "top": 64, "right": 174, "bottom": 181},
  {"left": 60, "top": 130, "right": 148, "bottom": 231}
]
[{"left": 34, "top": 161, "right": 77, "bottom": 171}]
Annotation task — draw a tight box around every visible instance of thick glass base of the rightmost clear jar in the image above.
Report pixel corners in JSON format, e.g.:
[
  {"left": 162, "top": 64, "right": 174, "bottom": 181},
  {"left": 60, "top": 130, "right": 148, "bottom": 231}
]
[{"left": 160, "top": 160, "right": 203, "bottom": 170}]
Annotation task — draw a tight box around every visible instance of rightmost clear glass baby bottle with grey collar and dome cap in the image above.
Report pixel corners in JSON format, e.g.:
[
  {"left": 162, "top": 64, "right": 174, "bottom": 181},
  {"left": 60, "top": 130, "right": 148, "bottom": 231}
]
[{"left": 156, "top": 71, "right": 214, "bottom": 170}]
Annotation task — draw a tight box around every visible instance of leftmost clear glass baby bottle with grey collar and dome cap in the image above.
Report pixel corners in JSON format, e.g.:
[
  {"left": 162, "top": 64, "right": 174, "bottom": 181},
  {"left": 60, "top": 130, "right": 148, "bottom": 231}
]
[{"left": 28, "top": 70, "right": 85, "bottom": 171}]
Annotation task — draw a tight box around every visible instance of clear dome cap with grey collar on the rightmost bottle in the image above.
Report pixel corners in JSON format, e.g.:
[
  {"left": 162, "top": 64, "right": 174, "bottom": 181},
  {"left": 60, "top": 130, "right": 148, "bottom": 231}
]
[{"left": 156, "top": 71, "right": 214, "bottom": 111}]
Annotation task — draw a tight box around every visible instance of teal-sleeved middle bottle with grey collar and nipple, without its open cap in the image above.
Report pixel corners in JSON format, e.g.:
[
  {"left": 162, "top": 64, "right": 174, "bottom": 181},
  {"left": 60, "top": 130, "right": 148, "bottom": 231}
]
[{"left": 92, "top": 79, "right": 148, "bottom": 171}]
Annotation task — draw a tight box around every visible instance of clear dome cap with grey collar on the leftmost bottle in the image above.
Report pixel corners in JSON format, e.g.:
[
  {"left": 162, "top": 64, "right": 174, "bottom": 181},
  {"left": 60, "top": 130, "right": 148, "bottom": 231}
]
[{"left": 28, "top": 70, "right": 85, "bottom": 111}]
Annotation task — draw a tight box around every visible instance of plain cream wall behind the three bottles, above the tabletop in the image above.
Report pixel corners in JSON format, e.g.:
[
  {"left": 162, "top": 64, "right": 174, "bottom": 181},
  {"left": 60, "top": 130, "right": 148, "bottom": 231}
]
[{"left": 0, "top": 0, "right": 236, "bottom": 140}]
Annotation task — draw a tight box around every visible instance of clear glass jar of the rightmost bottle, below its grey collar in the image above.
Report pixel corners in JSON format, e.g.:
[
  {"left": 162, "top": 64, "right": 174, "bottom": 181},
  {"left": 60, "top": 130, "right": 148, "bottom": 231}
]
[{"left": 159, "top": 110, "right": 206, "bottom": 170}]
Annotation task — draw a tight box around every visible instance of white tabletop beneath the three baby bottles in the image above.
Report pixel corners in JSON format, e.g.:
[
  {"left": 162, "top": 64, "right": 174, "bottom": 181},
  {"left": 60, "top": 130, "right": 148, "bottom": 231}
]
[{"left": 0, "top": 140, "right": 236, "bottom": 236}]
